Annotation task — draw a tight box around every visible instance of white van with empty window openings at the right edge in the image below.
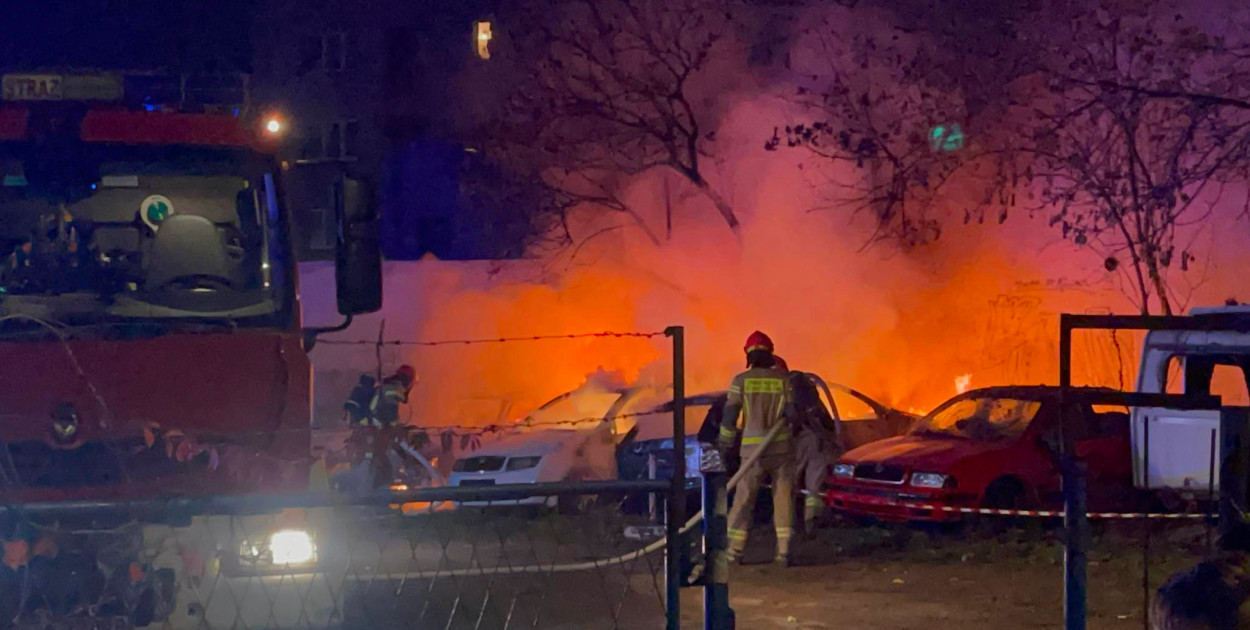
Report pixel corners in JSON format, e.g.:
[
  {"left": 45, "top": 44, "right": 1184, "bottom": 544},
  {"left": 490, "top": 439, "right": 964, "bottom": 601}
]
[{"left": 1133, "top": 305, "right": 1250, "bottom": 494}]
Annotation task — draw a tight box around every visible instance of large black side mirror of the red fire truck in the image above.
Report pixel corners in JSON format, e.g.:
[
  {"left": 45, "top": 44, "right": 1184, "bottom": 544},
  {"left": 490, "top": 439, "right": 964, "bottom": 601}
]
[{"left": 334, "top": 178, "right": 383, "bottom": 315}]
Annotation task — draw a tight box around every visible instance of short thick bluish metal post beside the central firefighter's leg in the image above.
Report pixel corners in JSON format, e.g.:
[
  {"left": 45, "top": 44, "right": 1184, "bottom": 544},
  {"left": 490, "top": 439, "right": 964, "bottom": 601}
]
[{"left": 700, "top": 444, "right": 734, "bottom": 630}]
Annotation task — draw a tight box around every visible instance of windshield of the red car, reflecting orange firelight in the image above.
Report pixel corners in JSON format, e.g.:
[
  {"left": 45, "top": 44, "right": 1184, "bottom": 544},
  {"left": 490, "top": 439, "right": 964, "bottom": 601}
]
[{"left": 911, "top": 396, "right": 1041, "bottom": 441}]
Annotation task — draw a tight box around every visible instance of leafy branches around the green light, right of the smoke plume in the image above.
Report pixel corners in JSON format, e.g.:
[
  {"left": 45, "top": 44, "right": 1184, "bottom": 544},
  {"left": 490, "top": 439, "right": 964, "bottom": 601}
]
[{"left": 765, "top": 18, "right": 989, "bottom": 246}]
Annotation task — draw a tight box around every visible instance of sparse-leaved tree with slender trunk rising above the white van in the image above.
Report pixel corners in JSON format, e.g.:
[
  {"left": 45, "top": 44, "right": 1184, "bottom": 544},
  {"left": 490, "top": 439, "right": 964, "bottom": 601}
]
[{"left": 1004, "top": 3, "right": 1250, "bottom": 314}]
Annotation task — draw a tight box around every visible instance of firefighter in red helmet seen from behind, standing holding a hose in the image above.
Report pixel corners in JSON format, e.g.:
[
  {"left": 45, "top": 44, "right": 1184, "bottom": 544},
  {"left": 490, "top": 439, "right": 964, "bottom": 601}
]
[{"left": 719, "top": 331, "right": 794, "bottom": 566}]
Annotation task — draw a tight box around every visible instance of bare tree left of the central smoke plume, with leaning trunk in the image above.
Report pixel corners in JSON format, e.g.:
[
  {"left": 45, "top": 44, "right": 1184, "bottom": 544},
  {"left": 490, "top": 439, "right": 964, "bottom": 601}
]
[{"left": 494, "top": 0, "right": 739, "bottom": 241}]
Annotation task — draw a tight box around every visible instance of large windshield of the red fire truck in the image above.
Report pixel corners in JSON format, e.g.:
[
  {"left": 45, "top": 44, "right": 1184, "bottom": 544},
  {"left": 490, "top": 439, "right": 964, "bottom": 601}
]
[{"left": 0, "top": 145, "right": 290, "bottom": 333}]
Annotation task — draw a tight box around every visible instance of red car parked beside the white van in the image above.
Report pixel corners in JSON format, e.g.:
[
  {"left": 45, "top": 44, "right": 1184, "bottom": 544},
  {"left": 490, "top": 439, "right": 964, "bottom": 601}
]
[{"left": 825, "top": 386, "right": 1133, "bottom": 521}]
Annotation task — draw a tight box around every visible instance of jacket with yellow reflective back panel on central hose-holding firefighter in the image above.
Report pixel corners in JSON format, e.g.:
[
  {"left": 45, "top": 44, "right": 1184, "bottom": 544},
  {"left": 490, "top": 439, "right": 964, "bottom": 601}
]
[{"left": 720, "top": 368, "right": 793, "bottom": 458}]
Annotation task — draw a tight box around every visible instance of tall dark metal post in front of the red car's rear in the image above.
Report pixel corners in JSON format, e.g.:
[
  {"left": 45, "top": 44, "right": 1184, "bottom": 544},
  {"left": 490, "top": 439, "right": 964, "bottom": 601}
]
[{"left": 1059, "top": 315, "right": 1089, "bottom": 630}]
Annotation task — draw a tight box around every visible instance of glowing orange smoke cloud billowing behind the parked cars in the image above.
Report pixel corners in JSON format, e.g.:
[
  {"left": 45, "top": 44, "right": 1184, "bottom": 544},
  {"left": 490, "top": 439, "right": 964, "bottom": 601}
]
[{"left": 314, "top": 3, "right": 1246, "bottom": 425}]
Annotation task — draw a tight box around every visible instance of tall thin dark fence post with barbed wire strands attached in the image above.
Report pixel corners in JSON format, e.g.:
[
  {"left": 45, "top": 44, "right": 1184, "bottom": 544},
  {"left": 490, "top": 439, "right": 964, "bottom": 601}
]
[{"left": 664, "top": 326, "right": 686, "bottom": 630}]
